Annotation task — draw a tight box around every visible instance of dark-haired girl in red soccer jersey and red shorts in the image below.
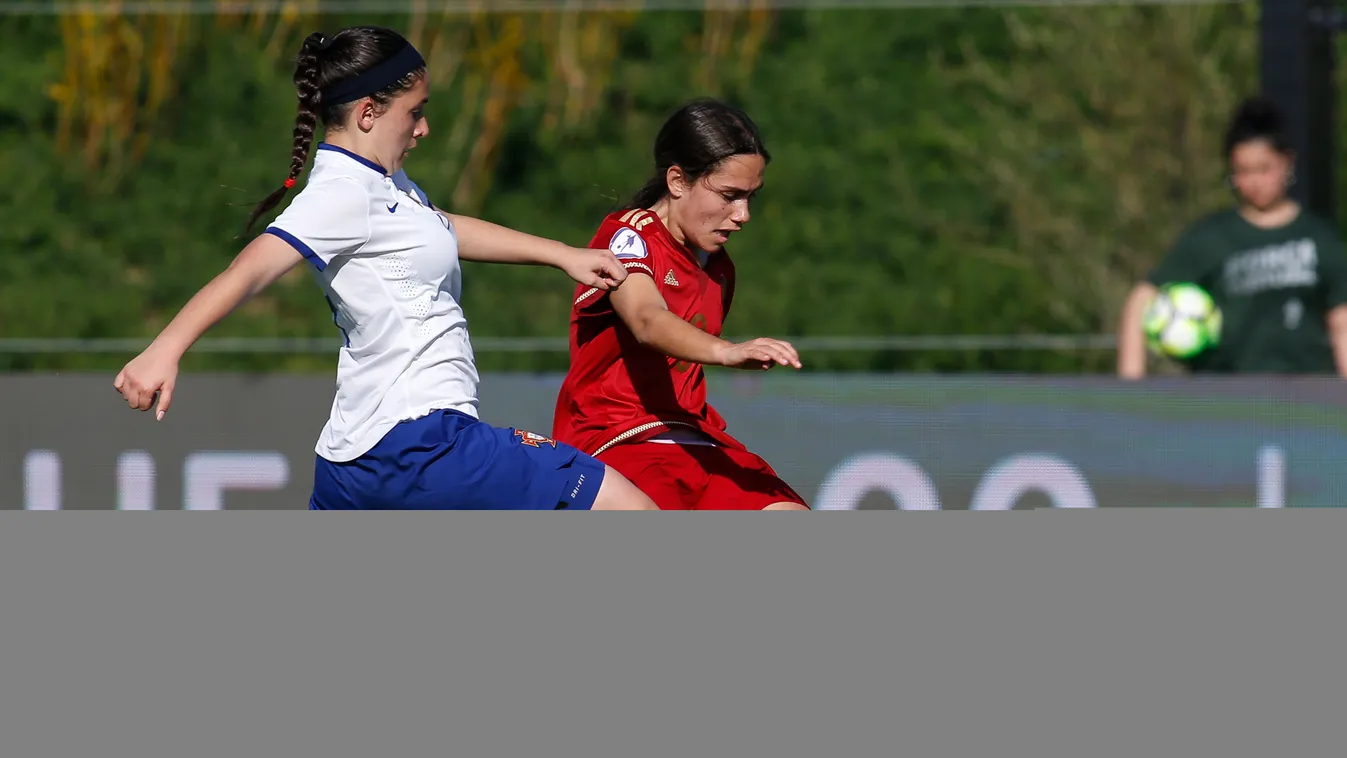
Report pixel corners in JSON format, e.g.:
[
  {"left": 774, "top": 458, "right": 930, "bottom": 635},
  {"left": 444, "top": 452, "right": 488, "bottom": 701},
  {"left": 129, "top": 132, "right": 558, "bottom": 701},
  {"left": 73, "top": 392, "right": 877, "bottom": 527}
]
[{"left": 554, "top": 100, "right": 808, "bottom": 510}]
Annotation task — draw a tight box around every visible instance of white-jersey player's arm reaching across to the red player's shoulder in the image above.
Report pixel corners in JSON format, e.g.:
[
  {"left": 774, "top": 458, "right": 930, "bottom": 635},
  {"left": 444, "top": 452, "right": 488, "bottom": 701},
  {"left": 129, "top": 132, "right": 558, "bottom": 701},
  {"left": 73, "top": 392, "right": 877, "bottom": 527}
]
[{"left": 440, "top": 211, "right": 626, "bottom": 291}]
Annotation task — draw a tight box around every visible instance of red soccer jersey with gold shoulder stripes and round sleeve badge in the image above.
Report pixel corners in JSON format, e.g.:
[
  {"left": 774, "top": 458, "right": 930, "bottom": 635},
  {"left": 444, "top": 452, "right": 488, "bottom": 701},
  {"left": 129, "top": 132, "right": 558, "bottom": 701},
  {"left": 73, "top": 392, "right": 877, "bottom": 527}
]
[{"left": 552, "top": 210, "right": 744, "bottom": 455}]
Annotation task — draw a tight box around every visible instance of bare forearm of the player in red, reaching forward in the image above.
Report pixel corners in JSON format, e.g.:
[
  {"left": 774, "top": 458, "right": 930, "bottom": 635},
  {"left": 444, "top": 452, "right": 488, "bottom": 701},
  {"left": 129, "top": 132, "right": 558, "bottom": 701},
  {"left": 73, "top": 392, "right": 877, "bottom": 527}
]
[{"left": 609, "top": 273, "right": 800, "bottom": 369}]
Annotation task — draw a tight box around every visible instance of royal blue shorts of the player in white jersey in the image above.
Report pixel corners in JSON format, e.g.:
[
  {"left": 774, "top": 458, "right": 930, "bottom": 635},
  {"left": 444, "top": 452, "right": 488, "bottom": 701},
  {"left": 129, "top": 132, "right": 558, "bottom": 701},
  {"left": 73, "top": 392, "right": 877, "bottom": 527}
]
[{"left": 308, "top": 411, "right": 605, "bottom": 510}]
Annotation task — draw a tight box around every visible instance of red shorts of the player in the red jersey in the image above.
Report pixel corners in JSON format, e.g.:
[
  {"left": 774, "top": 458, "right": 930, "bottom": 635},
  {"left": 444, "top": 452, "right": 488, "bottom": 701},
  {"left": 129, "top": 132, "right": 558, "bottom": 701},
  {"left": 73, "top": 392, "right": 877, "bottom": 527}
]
[{"left": 598, "top": 442, "right": 807, "bottom": 510}]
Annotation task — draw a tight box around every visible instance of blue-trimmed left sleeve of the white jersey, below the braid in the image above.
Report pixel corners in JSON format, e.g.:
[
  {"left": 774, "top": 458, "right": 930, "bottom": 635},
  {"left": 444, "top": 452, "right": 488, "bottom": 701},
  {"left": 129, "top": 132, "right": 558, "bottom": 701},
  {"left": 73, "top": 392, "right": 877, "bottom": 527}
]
[{"left": 267, "top": 179, "right": 369, "bottom": 271}]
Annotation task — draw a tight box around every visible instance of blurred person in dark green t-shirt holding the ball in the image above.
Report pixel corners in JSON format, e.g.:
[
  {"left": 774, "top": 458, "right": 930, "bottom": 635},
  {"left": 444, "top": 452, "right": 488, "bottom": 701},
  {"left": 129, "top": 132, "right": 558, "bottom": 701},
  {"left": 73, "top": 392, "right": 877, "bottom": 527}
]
[{"left": 1118, "top": 98, "right": 1347, "bottom": 378}]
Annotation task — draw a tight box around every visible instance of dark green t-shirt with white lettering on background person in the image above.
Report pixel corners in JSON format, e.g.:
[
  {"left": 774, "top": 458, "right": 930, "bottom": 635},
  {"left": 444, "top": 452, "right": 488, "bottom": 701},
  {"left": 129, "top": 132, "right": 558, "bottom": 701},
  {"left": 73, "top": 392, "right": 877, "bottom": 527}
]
[{"left": 1146, "top": 210, "right": 1347, "bottom": 374}]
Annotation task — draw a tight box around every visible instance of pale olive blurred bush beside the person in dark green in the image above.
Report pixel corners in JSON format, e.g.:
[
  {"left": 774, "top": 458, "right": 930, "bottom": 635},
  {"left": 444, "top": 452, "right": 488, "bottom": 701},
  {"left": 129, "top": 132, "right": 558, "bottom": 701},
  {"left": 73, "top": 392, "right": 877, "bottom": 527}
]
[{"left": 932, "top": 3, "right": 1258, "bottom": 368}]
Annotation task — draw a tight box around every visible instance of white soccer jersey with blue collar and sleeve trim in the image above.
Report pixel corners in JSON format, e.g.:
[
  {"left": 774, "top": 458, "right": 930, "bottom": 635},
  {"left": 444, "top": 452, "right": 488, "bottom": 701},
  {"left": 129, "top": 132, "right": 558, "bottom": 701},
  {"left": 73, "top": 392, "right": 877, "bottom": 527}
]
[{"left": 267, "top": 144, "right": 478, "bottom": 462}]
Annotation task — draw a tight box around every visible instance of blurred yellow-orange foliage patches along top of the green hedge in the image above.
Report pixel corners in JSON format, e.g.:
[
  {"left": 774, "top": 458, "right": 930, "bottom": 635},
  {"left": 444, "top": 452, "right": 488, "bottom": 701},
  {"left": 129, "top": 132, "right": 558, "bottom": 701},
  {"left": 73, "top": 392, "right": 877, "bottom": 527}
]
[{"left": 50, "top": 0, "right": 770, "bottom": 209}]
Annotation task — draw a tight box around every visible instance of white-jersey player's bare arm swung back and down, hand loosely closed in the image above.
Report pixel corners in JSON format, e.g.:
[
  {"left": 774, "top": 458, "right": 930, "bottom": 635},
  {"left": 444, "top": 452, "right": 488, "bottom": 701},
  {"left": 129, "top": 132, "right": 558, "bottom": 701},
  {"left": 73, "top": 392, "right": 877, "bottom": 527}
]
[{"left": 112, "top": 234, "right": 304, "bottom": 420}]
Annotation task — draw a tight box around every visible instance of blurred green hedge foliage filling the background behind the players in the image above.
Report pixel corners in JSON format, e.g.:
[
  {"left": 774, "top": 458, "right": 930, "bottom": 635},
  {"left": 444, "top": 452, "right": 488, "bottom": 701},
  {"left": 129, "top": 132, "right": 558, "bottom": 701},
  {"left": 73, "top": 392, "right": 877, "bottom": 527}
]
[{"left": 0, "top": 4, "right": 1325, "bottom": 372}]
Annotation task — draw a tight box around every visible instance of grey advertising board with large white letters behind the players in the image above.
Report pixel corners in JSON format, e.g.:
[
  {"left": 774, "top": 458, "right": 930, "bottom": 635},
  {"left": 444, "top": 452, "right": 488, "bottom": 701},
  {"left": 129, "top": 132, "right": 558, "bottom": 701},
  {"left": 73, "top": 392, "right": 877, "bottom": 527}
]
[{"left": 0, "top": 372, "right": 1347, "bottom": 510}]
